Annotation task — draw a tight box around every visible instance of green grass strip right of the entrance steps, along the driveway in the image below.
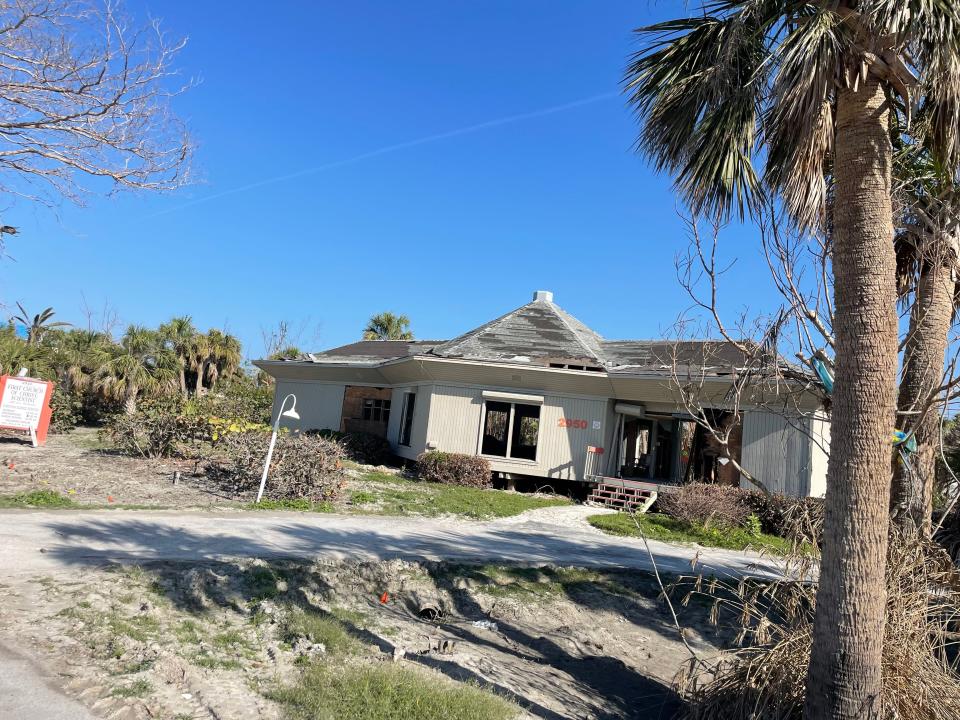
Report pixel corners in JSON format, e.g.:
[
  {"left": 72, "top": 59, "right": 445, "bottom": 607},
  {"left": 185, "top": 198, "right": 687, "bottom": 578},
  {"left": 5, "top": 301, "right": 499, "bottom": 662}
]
[{"left": 587, "top": 513, "right": 791, "bottom": 555}]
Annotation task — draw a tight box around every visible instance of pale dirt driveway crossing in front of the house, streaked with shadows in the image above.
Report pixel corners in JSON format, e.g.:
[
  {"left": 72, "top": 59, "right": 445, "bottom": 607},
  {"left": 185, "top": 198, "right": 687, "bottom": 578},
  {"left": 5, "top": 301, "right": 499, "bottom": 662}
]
[{"left": 0, "top": 506, "right": 776, "bottom": 579}]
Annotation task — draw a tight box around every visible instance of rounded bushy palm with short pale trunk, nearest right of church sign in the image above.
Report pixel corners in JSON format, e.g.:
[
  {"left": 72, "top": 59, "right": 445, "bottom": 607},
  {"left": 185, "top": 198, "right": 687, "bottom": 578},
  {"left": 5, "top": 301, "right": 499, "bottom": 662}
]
[{"left": 94, "top": 325, "right": 177, "bottom": 415}]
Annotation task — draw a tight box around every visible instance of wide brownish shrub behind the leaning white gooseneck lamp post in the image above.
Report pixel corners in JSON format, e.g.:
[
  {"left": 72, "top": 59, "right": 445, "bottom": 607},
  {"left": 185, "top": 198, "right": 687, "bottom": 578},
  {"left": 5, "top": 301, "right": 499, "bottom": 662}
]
[{"left": 206, "top": 431, "right": 346, "bottom": 503}]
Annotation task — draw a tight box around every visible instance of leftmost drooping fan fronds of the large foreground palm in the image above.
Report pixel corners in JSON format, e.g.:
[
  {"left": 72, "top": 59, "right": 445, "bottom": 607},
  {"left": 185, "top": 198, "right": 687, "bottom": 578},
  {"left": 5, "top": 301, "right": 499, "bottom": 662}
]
[{"left": 624, "top": 0, "right": 778, "bottom": 216}]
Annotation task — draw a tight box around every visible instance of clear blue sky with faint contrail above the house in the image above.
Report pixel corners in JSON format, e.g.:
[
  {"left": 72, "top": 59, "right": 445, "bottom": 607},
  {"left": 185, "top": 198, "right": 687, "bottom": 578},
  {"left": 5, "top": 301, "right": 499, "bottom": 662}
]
[{"left": 0, "top": 0, "right": 773, "bottom": 357}]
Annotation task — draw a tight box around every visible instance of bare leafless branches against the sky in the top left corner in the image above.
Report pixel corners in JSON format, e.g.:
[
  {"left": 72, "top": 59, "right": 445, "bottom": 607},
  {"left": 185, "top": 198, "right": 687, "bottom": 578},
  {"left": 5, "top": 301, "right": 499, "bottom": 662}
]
[{"left": 0, "top": 0, "right": 193, "bottom": 217}]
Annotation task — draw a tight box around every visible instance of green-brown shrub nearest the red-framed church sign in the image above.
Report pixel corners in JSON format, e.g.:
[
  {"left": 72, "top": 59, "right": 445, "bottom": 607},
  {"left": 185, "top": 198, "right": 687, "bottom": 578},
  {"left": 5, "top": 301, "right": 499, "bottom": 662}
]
[{"left": 102, "top": 398, "right": 209, "bottom": 458}]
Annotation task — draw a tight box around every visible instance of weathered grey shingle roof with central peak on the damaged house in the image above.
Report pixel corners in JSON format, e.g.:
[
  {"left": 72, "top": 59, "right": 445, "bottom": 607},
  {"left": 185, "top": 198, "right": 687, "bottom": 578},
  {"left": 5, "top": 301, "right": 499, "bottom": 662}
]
[{"left": 260, "top": 290, "right": 764, "bottom": 376}]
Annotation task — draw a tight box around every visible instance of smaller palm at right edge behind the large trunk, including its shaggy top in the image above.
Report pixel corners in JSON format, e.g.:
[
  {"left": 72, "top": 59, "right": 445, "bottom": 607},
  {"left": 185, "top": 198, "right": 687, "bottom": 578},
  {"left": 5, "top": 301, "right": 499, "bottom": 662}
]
[{"left": 890, "top": 146, "right": 960, "bottom": 534}]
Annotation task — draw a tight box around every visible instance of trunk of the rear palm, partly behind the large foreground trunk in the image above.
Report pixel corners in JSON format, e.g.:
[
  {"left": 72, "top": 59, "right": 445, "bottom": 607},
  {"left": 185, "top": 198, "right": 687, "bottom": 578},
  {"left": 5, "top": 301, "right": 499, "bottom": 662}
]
[{"left": 890, "top": 253, "right": 955, "bottom": 534}]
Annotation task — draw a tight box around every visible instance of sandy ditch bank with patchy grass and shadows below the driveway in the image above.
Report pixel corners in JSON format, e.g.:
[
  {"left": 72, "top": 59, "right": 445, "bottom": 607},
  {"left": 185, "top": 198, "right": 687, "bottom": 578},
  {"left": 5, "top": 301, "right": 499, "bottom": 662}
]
[{"left": 0, "top": 560, "right": 728, "bottom": 720}]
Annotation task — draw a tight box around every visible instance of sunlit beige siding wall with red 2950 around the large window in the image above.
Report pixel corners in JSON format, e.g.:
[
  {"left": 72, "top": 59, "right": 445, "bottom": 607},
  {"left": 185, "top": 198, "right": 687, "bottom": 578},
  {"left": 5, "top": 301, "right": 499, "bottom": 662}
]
[{"left": 426, "top": 385, "right": 609, "bottom": 479}]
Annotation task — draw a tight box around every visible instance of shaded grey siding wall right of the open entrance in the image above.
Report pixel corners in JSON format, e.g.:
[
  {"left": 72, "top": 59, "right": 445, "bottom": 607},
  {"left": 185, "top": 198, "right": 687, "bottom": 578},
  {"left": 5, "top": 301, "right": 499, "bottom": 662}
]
[{"left": 741, "top": 410, "right": 814, "bottom": 496}]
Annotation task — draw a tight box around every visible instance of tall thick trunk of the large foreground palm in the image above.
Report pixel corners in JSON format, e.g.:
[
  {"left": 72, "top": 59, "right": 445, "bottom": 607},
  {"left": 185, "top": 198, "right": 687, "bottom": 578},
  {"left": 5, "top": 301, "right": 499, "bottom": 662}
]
[{"left": 804, "top": 79, "right": 897, "bottom": 720}]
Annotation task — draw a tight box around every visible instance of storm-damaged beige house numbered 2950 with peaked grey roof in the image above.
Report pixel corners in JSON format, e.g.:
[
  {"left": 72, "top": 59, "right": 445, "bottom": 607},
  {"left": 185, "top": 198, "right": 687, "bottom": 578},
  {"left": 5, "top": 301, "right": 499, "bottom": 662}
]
[{"left": 255, "top": 291, "right": 829, "bottom": 496}]
